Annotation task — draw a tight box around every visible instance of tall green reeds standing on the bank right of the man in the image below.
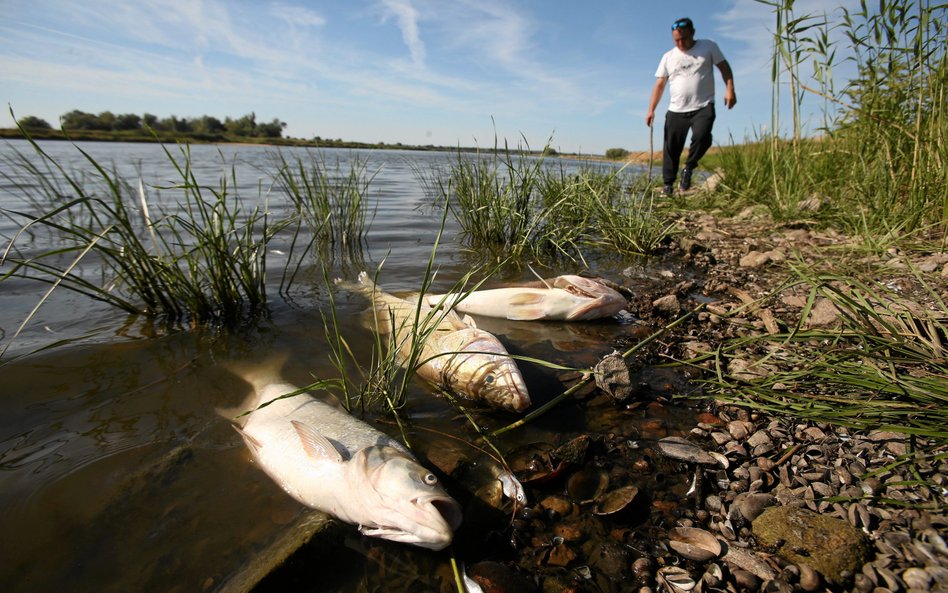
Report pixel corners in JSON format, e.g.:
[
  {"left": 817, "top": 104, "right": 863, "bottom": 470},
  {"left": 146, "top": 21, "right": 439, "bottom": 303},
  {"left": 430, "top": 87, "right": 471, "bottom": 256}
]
[{"left": 722, "top": 0, "right": 948, "bottom": 239}]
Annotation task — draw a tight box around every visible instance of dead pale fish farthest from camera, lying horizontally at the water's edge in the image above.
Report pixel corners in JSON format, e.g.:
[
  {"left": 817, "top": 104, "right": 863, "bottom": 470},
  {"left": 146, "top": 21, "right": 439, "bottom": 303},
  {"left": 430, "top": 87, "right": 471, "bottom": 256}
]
[{"left": 426, "top": 275, "right": 627, "bottom": 321}]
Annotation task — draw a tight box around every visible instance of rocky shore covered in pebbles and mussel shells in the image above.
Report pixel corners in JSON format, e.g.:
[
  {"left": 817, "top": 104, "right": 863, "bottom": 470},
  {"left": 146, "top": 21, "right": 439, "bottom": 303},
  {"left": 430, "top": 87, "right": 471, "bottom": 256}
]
[{"left": 468, "top": 205, "right": 948, "bottom": 593}]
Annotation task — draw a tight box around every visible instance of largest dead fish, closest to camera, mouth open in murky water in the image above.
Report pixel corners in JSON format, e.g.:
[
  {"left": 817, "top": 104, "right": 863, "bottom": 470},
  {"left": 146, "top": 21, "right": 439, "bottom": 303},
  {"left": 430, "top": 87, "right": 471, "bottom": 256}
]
[{"left": 222, "top": 354, "right": 462, "bottom": 550}]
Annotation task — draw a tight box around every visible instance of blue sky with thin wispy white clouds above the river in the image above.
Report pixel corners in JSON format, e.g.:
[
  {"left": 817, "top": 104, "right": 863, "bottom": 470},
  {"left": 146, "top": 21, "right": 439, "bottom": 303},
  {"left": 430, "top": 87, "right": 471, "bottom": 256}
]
[{"left": 0, "top": 0, "right": 857, "bottom": 154}]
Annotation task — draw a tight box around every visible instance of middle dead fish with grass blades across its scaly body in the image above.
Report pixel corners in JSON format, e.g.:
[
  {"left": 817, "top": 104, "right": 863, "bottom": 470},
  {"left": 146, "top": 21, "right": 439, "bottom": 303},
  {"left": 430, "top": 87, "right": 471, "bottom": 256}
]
[{"left": 340, "top": 272, "right": 530, "bottom": 412}]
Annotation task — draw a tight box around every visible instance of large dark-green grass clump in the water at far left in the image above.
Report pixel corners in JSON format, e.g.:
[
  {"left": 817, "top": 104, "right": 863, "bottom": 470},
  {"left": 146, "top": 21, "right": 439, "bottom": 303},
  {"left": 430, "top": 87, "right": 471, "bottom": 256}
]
[{"left": 0, "top": 133, "right": 285, "bottom": 346}]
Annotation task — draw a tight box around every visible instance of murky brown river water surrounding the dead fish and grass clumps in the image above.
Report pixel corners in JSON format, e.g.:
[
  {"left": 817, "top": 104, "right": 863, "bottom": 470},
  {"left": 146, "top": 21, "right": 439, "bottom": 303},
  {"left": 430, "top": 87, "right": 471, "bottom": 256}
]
[{"left": 0, "top": 142, "right": 693, "bottom": 592}]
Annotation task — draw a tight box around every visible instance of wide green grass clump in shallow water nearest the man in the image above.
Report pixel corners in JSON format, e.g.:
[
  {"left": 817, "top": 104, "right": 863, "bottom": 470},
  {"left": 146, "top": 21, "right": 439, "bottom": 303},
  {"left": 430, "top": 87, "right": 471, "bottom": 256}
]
[{"left": 438, "top": 139, "right": 672, "bottom": 264}]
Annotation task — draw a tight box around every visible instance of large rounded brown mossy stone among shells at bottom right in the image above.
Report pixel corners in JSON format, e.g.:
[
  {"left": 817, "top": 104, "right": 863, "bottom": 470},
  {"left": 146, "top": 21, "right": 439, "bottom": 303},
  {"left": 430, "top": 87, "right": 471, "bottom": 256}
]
[{"left": 752, "top": 506, "right": 869, "bottom": 585}]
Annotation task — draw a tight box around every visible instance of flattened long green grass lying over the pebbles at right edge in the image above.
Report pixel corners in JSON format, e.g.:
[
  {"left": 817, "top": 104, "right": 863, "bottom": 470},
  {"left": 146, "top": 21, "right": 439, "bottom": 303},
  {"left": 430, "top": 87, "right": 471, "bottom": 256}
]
[{"left": 688, "top": 268, "right": 948, "bottom": 441}]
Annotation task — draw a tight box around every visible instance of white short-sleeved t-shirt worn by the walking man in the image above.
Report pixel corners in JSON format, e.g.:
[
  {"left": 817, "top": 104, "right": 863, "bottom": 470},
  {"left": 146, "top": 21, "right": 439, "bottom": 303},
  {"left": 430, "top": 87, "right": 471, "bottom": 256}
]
[{"left": 655, "top": 39, "right": 724, "bottom": 113}]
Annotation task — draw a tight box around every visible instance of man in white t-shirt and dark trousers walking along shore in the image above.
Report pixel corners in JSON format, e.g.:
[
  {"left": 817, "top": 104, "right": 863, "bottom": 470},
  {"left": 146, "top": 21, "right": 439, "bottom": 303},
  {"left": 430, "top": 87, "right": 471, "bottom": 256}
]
[{"left": 645, "top": 18, "right": 737, "bottom": 196}]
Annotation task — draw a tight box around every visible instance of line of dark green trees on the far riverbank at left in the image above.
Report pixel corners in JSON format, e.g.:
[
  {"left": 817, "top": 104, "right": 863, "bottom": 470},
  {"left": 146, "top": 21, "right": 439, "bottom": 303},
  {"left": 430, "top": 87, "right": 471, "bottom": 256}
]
[{"left": 19, "top": 109, "right": 286, "bottom": 138}]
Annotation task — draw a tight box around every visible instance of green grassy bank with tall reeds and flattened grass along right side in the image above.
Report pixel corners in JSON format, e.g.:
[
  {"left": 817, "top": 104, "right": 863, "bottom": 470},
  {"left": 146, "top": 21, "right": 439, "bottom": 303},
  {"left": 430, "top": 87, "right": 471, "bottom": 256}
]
[{"left": 677, "top": 2, "right": 948, "bottom": 440}]
